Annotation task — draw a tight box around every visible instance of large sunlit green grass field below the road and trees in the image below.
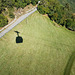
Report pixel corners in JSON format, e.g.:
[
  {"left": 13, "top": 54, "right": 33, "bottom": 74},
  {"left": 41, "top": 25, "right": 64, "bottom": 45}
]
[{"left": 0, "top": 12, "right": 75, "bottom": 75}]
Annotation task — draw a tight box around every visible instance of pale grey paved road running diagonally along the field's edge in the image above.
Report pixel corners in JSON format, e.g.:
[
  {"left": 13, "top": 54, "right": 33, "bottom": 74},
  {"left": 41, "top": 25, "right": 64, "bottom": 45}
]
[{"left": 0, "top": 8, "right": 37, "bottom": 38}]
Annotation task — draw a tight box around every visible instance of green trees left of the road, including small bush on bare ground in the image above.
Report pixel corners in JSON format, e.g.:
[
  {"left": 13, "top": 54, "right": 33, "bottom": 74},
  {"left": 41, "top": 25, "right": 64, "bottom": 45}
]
[{"left": 0, "top": 0, "right": 39, "bottom": 27}]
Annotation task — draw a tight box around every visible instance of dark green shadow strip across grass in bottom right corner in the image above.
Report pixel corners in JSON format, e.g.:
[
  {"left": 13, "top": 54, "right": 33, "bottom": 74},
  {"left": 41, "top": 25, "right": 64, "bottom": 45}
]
[{"left": 64, "top": 52, "right": 75, "bottom": 75}]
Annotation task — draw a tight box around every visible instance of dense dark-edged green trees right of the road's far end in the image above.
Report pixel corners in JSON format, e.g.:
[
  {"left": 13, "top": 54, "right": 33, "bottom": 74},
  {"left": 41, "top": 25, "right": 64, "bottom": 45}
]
[{"left": 38, "top": 0, "right": 75, "bottom": 31}]
